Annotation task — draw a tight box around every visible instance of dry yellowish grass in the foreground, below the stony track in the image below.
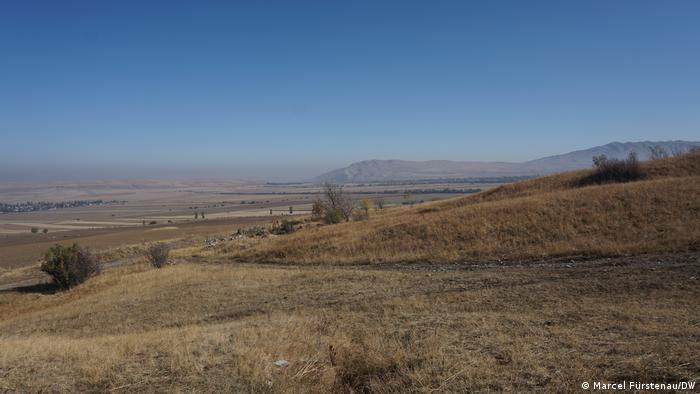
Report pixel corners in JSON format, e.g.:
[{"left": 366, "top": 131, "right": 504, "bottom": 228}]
[{"left": 0, "top": 253, "right": 700, "bottom": 393}]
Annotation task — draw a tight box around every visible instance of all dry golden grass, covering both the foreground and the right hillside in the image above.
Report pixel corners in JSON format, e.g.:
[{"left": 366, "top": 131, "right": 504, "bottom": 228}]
[{"left": 0, "top": 152, "right": 700, "bottom": 393}]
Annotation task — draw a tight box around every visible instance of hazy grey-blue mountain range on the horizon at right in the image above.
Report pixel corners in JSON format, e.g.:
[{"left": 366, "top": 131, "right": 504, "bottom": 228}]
[{"left": 313, "top": 141, "right": 700, "bottom": 183}]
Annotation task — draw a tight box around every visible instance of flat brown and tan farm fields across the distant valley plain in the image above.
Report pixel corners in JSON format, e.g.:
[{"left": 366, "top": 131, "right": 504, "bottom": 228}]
[{"left": 0, "top": 181, "right": 498, "bottom": 270}]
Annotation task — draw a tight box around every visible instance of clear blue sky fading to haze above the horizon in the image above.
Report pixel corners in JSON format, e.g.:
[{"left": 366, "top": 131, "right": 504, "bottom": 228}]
[{"left": 0, "top": 0, "right": 700, "bottom": 180}]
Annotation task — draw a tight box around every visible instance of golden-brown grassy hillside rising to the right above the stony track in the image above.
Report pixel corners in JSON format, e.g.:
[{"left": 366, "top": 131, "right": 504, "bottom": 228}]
[{"left": 224, "top": 152, "right": 700, "bottom": 264}]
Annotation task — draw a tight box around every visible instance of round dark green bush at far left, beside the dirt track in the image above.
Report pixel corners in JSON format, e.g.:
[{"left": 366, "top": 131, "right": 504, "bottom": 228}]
[{"left": 41, "top": 244, "right": 100, "bottom": 290}]
